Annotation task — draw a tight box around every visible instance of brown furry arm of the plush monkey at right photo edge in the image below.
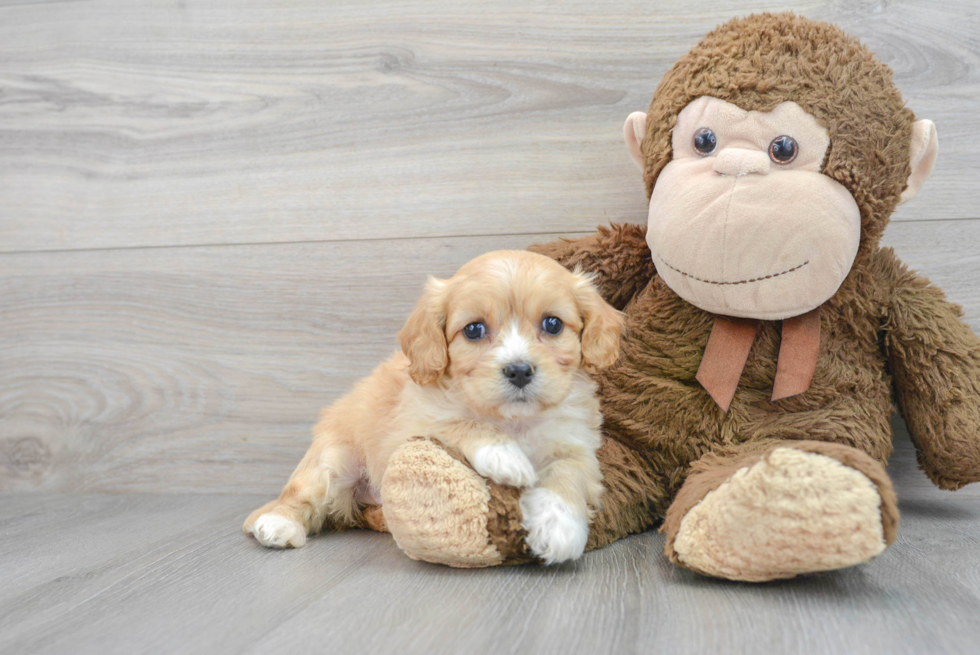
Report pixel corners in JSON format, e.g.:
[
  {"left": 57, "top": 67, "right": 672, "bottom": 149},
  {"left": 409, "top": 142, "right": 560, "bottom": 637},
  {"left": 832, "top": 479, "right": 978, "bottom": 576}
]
[{"left": 880, "top": 249, "right": 980, "bottom": 489}]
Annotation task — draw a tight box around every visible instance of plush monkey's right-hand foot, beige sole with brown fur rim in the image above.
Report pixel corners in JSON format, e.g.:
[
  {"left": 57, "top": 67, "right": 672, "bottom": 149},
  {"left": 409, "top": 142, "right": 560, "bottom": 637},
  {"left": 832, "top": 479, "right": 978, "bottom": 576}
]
[{"left": 662, "top": 441, "right": 898, "bottom": 582}]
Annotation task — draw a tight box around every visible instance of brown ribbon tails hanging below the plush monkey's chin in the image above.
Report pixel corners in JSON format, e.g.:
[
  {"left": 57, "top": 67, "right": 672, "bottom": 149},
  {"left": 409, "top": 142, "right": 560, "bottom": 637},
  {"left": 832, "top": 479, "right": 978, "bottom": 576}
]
[{"left": 696, "top": 307, "right": 820, "bottom": 412}]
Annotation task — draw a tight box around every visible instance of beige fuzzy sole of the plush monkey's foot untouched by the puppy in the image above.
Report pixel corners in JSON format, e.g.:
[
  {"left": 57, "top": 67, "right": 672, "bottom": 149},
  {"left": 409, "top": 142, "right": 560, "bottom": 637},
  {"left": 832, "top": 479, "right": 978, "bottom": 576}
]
[{"left": 673, "top": 448, "right": 886, "bottom": 582}]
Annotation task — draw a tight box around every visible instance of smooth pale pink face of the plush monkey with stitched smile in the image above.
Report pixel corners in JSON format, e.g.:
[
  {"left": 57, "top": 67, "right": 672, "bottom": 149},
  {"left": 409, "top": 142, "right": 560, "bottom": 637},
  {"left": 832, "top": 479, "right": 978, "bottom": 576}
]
[{"left": 647, "top": 97, "right": 861, "bottom": 320}]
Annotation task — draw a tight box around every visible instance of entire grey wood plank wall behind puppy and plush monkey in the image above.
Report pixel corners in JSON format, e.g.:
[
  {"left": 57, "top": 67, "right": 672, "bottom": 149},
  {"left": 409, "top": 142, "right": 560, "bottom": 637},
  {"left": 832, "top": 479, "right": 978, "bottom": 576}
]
[{"left": 0, "top": 0, "right": 980, "bottom": 493}]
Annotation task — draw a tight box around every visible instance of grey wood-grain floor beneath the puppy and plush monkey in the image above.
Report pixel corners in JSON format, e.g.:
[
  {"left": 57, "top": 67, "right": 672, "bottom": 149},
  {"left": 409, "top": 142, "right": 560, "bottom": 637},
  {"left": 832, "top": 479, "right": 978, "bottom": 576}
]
[{"left": 0, "top": 430, "right": 980, "bottom": 655}]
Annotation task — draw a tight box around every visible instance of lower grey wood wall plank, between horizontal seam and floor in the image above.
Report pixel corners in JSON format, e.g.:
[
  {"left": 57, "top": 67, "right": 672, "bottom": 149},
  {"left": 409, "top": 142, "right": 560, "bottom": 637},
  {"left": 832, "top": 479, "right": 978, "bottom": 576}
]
[{"left": 0, "top": 221, "right": 980, "bottom": 494}]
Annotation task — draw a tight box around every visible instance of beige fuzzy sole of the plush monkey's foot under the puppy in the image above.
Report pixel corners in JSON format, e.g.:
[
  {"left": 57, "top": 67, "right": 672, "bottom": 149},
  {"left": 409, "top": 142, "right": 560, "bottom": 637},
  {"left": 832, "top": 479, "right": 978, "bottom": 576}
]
[{"left": 381, "top": 439, "right": 503, "bottom": 568}]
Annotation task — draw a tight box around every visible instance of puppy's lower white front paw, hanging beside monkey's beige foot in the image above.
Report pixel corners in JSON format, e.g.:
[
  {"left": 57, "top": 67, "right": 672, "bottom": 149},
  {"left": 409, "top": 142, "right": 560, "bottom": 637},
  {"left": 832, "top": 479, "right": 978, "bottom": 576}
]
[{"left": 521, "top": 488, "right": 589, "bottom": 564}]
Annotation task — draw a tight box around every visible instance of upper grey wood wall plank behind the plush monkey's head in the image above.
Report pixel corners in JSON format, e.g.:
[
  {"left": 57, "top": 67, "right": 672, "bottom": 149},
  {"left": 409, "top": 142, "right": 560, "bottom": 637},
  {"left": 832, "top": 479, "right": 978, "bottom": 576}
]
[{"left": 0, "top": 0, "right": 980, "bottom": 252}]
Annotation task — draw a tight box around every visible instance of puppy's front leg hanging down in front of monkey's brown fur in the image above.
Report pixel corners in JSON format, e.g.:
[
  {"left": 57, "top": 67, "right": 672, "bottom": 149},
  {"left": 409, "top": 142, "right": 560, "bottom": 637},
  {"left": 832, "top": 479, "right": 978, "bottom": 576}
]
[{"left": 521, "top": 446, "right": 603, "bottom": 564}]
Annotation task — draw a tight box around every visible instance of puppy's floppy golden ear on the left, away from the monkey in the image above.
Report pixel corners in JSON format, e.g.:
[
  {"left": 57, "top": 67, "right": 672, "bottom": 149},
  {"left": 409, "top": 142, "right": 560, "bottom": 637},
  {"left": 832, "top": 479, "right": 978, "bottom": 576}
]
[{"left": 398, "top": 277, "right": 449, "bottom": 385}]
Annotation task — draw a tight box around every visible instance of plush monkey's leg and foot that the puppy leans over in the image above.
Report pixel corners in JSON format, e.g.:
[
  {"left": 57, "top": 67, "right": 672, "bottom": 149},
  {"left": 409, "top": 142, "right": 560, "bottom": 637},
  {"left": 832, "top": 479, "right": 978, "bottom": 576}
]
[{"left": 381, "top": 438, "right": 664, "bottom": 568}]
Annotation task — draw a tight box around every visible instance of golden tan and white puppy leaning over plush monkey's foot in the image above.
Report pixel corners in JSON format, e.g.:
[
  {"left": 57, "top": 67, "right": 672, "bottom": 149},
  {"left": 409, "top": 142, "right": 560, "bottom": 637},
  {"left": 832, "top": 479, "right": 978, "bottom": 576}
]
[{"left": 244, "top": 251, "right": 623, "bottom": 564}]
